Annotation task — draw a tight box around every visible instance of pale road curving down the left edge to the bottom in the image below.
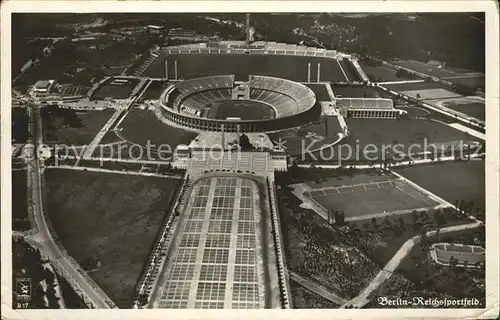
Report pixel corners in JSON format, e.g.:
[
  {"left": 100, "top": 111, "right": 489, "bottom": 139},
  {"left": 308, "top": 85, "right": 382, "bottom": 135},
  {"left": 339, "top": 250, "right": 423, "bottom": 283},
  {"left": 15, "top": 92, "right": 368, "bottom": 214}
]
[{"left": 26, "top": 105, "right": 112, "bottom": 309}]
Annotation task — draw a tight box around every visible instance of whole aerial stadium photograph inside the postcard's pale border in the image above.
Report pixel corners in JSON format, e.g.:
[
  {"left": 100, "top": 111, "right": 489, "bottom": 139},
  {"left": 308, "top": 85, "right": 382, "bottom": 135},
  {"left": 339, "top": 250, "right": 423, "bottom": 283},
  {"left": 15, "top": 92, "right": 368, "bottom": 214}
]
[{"left": 7, "top": 12, "right": 490, "bottom": 309}]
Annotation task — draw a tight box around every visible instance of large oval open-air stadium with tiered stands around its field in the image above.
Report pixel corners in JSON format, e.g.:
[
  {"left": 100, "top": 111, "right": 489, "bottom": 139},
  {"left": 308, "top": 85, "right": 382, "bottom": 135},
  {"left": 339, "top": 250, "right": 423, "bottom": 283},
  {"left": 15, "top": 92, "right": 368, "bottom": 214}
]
[{"left": 160, "top": 75, "right": 321, "bottom": 132}]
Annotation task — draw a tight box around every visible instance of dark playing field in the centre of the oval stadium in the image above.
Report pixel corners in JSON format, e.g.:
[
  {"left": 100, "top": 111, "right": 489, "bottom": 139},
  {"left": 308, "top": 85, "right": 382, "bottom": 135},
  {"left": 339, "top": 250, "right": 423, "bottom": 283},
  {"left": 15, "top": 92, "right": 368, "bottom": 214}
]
[{"left": 207, "top": 100, "right": 276, "bottom": 120}]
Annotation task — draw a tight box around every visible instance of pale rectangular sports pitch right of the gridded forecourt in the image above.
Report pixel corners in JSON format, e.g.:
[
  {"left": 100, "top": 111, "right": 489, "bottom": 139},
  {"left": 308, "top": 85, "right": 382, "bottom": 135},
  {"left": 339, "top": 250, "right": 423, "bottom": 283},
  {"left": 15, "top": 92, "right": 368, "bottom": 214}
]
[{"left": 300, "top": 179, "right": 437, "bottom": 219}]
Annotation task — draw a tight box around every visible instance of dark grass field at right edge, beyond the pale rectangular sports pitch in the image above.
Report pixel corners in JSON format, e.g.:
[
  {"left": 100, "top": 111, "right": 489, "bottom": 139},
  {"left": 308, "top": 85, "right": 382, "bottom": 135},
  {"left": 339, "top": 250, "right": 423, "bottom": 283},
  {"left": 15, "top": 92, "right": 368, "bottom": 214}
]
[{"left": 396, "top": 161, "right": 485, "bottom": 211}]
